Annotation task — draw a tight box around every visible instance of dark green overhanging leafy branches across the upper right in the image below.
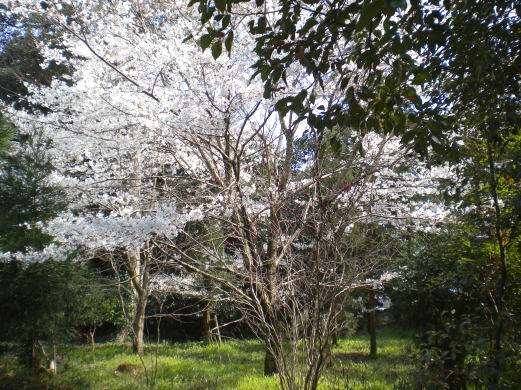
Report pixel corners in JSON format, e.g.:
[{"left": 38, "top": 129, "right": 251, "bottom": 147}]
[{"left": 190, "top": 0, "right": 520, "bottom": 155}]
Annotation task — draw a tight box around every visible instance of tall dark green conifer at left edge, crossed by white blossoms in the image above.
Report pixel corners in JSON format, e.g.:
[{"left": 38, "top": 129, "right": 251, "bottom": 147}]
[{"left": 0, "top": 131, "right": 120, "bottom": 371}]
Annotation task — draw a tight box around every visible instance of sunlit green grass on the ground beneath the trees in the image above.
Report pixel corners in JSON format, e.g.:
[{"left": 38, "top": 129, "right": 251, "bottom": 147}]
[{"left": 0, "top": 332, "right": 412, "bottom": 390}]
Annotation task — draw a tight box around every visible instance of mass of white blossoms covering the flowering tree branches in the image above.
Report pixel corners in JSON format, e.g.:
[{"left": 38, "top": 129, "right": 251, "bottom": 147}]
[{"left": 2, "top": 0, "right": 451, "bottom": 296}]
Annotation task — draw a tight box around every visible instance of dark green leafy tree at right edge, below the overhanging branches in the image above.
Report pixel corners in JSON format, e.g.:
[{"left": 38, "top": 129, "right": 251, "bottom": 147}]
[{"left": 389, "top": 126, "right": 519, "bottom": 389}]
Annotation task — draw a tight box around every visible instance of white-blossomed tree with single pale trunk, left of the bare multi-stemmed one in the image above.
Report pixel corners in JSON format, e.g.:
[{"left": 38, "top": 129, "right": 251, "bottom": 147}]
[{"left": 6, "top": 2, "right": 220, "bottom": 353}]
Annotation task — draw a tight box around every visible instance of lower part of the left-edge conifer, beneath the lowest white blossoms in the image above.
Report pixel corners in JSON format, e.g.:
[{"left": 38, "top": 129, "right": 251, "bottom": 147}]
[{"left": 0, "top": 259, "right": 117, "bottom": 372}]
